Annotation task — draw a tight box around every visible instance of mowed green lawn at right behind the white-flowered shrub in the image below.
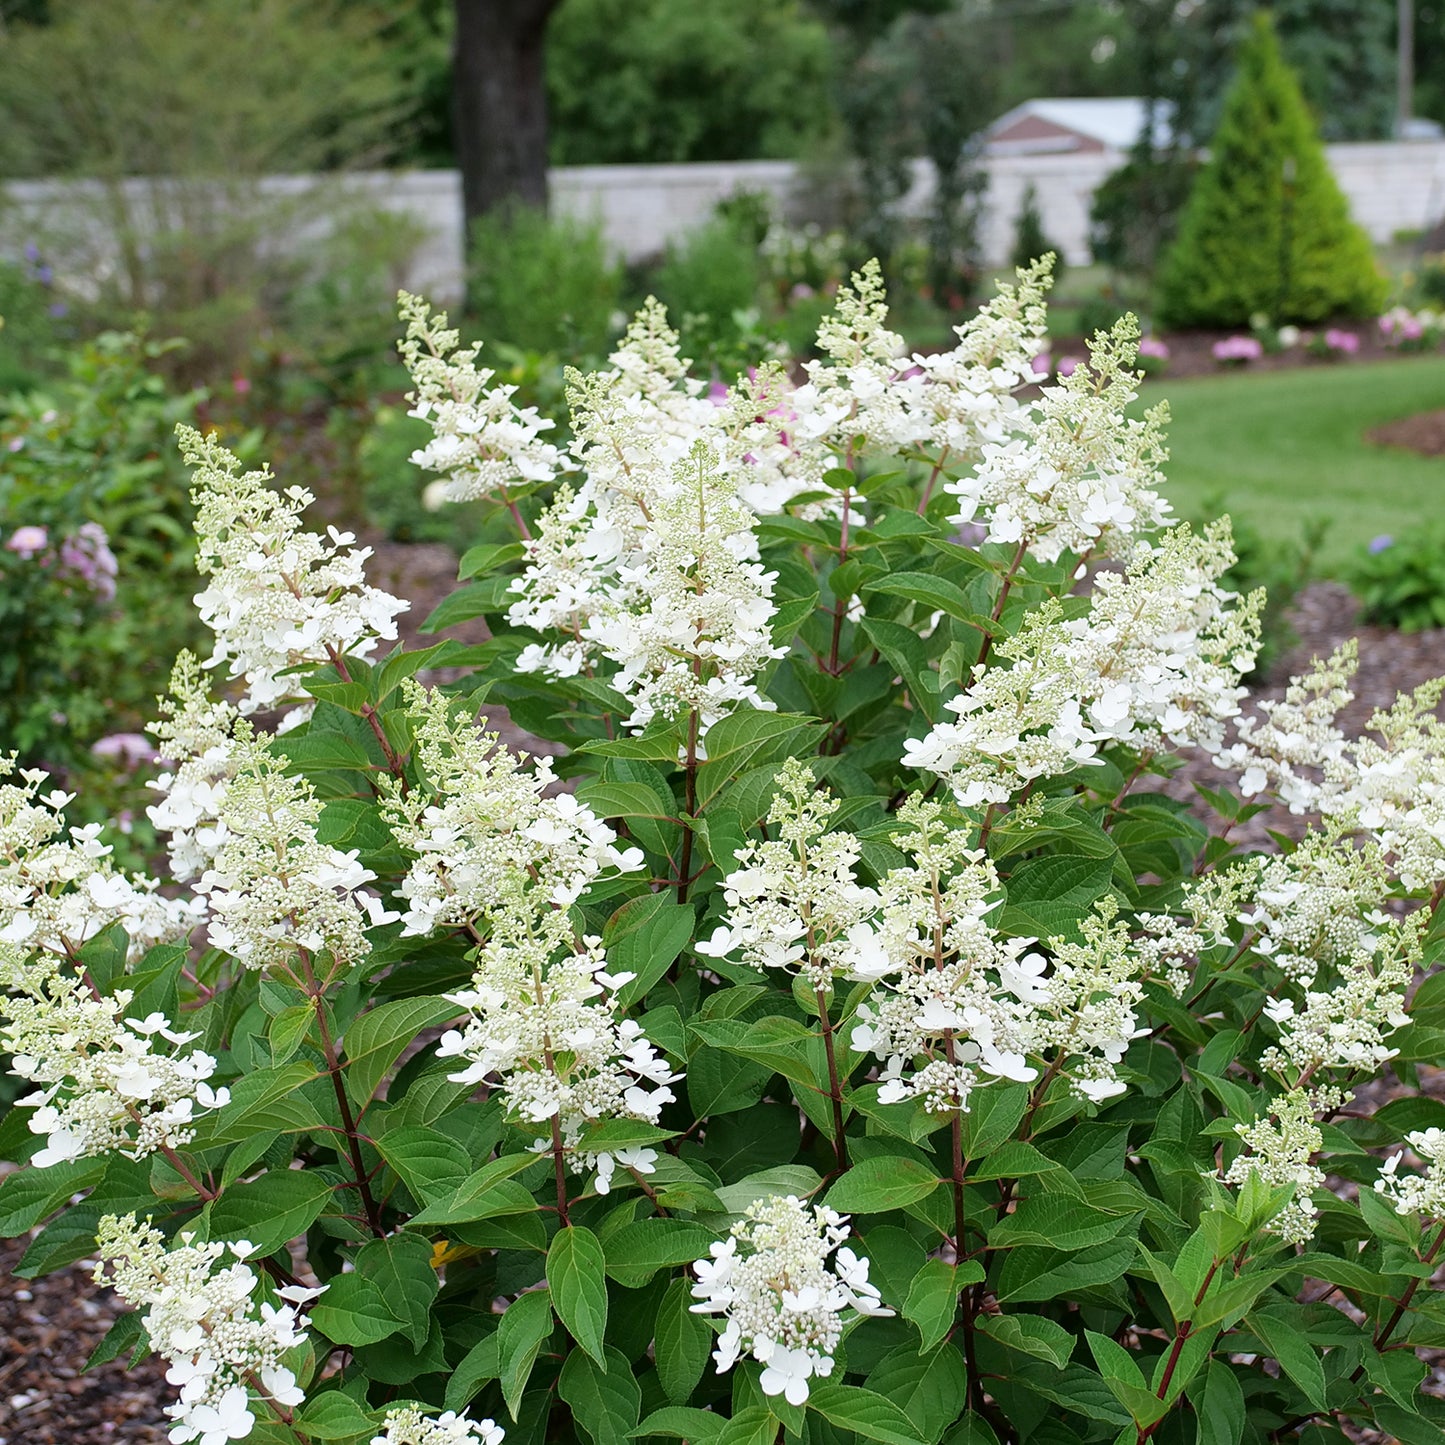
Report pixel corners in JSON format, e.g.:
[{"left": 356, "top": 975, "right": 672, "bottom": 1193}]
[{"left": 1144, "top": 357, "right": 1445, "bottom": 575}]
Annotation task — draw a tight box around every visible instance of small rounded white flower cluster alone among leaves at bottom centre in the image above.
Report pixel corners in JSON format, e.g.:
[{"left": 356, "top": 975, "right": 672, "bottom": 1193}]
[{"left": 692, "top": 1195, "right": 893, "bottom": 1405}]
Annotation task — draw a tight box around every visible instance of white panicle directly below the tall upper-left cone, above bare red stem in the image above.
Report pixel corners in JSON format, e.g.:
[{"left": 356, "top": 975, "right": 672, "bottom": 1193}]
[{"left": 197, "top": 720, "right": 397, "bottom": 972}]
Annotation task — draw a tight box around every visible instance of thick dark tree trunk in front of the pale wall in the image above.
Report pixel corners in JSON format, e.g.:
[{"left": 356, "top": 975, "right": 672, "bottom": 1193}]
[{"left": 452, "top": 0, "right": 558, "bottom": 234}]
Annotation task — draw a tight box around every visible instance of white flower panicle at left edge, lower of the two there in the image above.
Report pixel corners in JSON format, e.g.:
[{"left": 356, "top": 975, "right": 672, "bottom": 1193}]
[{"left": 0, "top": 945, "right": 230, "bottom": 1169}]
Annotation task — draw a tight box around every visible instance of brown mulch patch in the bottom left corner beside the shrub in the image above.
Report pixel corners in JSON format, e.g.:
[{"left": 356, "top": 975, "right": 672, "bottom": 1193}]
[{"left": 0, "top": 1240, "right": 175, "bottom": 1445}]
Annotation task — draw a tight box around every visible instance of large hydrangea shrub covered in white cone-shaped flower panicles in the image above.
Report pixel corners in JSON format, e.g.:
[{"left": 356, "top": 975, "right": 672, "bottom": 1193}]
[{"left": 8, "top": 266, "right": 1445, "bottom": 1445}]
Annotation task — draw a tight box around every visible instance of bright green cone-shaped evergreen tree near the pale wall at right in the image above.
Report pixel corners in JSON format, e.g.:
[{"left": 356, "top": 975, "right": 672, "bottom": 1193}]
[{"left": 1159, "top": 13, "right": 1384, "bottom": 327}]
